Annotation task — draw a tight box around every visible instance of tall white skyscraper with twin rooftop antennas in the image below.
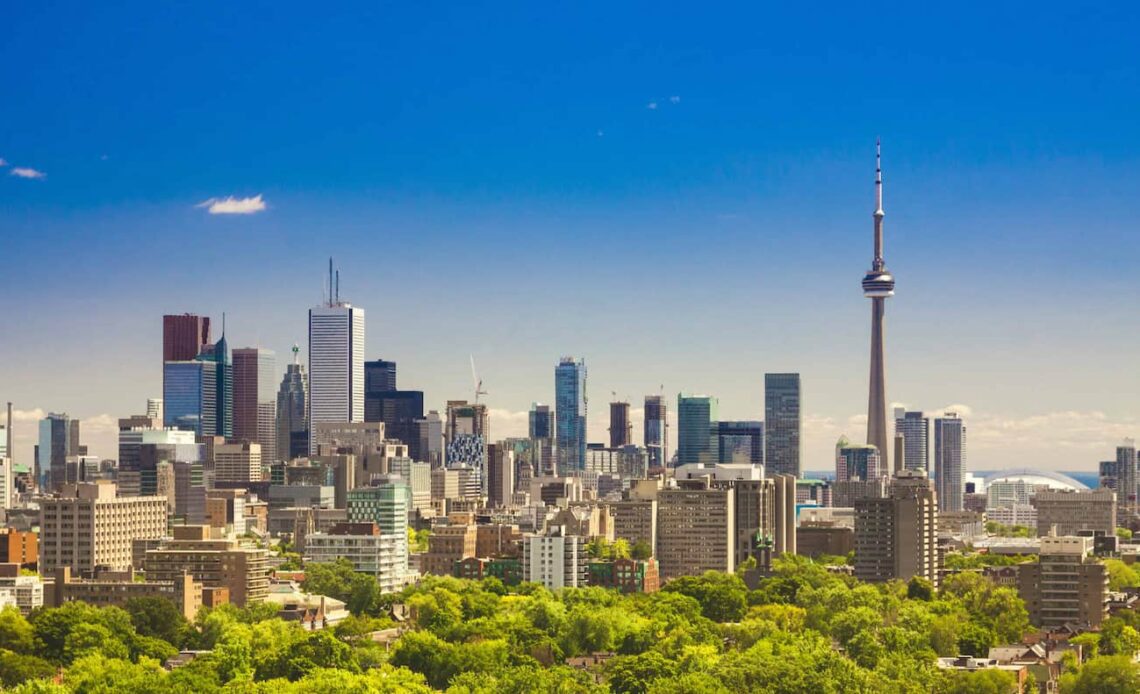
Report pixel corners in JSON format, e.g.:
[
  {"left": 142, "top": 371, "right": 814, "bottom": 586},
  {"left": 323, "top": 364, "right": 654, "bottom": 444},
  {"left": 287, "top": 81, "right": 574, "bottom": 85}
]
[{"left": 309, "top": 259, "right": 365, "bottom": 452}]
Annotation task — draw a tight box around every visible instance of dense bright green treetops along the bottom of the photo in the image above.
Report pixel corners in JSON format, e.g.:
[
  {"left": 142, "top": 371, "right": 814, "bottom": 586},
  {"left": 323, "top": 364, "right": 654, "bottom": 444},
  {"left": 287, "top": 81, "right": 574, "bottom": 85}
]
[{"left": 0, "top": 557, "right": 1140, "bottom": 694}]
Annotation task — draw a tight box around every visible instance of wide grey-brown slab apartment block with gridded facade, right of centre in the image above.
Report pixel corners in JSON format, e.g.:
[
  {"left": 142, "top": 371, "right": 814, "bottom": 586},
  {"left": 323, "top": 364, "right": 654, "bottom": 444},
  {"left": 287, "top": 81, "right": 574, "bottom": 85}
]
[{"left": 657, "top": 477, "right": 736, "bottom": 580}]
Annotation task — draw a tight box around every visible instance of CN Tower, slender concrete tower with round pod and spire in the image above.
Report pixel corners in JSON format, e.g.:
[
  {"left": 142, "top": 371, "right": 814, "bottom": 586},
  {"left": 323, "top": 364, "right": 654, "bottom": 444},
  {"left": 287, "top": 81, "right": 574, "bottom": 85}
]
[{"left": 863, "top": 140, "right": 895, "bottom": 471}]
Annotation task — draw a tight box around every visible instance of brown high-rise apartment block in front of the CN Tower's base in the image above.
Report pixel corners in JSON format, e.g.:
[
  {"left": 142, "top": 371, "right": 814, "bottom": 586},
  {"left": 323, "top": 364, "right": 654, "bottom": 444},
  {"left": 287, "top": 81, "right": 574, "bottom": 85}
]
[{"left": 855, "top": 470, "right": 939, "bottom": 586}]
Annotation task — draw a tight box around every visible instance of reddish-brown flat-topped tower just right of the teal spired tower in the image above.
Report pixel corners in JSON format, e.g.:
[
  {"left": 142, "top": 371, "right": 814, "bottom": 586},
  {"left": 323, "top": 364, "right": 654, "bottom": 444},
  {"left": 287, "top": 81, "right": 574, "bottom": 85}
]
[{"left": 234, "top": 348, "right": 278, "bottom": 463}]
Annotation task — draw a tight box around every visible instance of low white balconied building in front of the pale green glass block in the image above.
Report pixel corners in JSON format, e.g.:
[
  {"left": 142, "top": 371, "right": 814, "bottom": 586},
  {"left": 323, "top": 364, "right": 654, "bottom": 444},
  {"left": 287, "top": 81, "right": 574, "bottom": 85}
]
[{"left": 304, "top": 522, "right": 408, "bottom": 593}]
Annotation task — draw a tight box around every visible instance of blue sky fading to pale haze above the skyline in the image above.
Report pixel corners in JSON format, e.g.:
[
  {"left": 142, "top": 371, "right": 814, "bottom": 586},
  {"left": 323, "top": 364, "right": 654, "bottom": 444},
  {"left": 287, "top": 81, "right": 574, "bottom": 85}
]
[{"left": 0, "top": 2, "right": 1140, "bottom": 470}]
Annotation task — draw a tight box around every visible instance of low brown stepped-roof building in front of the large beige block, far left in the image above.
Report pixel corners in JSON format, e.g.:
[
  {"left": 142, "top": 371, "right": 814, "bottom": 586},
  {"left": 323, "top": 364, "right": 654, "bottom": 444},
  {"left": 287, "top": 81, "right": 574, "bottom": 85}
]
[{"left": 146, "top": 525, "right": 269, "bottom": 607}]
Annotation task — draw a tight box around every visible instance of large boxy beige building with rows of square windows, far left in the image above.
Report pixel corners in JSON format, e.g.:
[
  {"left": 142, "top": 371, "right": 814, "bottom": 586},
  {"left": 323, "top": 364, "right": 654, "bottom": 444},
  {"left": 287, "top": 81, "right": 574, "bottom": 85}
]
[{"left": 39, "top": 482, "right": 166, "bottom": 574}]
